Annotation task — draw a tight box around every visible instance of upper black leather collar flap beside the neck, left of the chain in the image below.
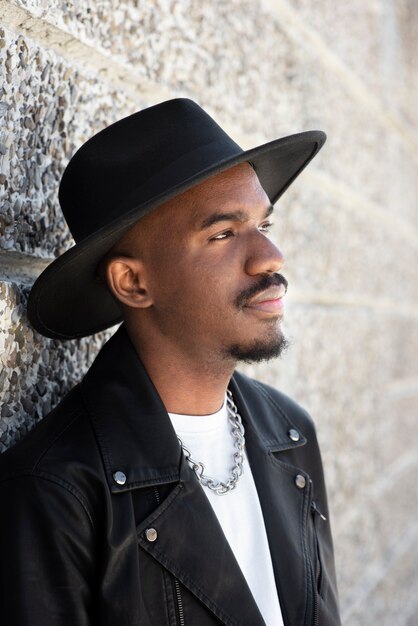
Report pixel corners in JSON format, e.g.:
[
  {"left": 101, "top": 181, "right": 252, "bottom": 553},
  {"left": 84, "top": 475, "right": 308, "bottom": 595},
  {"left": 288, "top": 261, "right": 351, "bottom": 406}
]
[{"left": 81, "top": 326, "right": 181, "bottom": 493}]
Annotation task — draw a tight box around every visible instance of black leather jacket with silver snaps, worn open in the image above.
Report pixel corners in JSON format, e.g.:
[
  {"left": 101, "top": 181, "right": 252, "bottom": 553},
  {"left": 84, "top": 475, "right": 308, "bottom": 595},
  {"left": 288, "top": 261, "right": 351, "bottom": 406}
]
[{"left": 0, "top": 327, "right": 340, "bottom": 626}]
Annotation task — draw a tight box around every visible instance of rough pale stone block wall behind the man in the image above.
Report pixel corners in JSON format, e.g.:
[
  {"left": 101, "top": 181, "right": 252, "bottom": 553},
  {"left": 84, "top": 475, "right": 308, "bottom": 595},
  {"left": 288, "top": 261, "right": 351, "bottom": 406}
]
[{"left": 0, "top": 0, "right": 418, "bottom": 626}]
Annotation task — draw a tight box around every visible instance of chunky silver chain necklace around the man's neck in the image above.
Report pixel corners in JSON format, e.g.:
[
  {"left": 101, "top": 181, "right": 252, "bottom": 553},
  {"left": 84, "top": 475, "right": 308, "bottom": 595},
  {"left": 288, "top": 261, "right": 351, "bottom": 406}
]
[{"left": 177, "top": 389, "right": 245, "bottom": 496}]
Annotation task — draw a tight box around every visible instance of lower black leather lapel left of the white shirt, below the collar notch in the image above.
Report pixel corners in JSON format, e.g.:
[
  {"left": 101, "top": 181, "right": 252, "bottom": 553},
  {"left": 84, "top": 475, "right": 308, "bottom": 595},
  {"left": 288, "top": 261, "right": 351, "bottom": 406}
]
[{"left": 137, "top": 457, "right": 265, "bottom": 626}]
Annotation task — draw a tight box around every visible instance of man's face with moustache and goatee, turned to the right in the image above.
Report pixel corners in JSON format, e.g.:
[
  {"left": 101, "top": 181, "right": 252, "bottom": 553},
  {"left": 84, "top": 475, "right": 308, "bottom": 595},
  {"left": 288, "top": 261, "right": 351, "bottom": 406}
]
[{"left": 116, "top": 163, "right": 287, "bottom": 361}]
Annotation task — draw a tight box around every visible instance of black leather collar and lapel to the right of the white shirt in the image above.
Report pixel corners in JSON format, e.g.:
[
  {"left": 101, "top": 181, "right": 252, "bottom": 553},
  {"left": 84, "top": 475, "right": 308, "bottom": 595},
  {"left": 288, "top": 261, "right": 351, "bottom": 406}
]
[{"left": 231, "top": 375, "right": 312, "bottom": 625}]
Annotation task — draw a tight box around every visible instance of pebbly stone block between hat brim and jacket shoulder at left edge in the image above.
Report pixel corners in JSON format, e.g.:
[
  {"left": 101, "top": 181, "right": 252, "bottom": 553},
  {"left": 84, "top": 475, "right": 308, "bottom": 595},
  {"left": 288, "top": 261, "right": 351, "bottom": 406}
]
[{"left": 0, "top": 283, "right": 111, "bottom": 452}]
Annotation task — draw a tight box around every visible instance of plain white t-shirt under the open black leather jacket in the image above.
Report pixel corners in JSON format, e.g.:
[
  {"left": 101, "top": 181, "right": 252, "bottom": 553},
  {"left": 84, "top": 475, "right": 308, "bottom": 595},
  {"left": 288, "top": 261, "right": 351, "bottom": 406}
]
[{"left": 169, "top": 400, "right": 283, "bottom": 626}]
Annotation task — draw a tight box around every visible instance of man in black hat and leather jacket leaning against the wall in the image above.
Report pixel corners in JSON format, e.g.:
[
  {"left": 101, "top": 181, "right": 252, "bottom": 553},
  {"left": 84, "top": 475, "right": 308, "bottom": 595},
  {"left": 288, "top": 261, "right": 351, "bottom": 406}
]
[{"left": 0, "top": 99, "right": 340, "bottom": 626}]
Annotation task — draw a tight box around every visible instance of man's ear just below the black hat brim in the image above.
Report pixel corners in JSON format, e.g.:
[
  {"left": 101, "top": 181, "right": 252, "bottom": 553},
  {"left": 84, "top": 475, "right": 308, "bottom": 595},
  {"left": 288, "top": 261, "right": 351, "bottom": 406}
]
[{"left": 106, "top": 256, "right": 152, "bottom": 309}]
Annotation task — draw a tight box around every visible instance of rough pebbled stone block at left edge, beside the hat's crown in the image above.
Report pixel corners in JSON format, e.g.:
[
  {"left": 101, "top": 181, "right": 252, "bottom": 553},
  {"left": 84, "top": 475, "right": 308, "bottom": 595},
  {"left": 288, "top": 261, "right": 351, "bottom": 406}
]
[{"left": 0, "top": 30, "right": 141, "bottom": 257}]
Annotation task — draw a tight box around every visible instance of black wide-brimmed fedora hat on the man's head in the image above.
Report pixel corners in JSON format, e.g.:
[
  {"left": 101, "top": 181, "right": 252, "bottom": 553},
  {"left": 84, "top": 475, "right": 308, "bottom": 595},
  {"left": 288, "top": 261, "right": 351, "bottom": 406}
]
[{"left": 28, "top": 98, "right": 326, "bottom": 339}]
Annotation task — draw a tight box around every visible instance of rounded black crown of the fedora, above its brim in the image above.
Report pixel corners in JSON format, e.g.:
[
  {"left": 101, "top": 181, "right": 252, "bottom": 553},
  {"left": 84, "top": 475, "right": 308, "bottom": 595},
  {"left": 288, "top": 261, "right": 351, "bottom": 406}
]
[{"left": 59, "top": 98, "right": 242, "bottom": 242}]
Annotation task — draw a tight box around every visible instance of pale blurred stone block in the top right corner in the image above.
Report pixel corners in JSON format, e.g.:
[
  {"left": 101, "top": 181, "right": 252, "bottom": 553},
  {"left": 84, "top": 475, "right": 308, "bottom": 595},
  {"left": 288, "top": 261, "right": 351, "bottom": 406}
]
[{"left": 289, "top": 0, "right": 418, "bottom": 125}]
